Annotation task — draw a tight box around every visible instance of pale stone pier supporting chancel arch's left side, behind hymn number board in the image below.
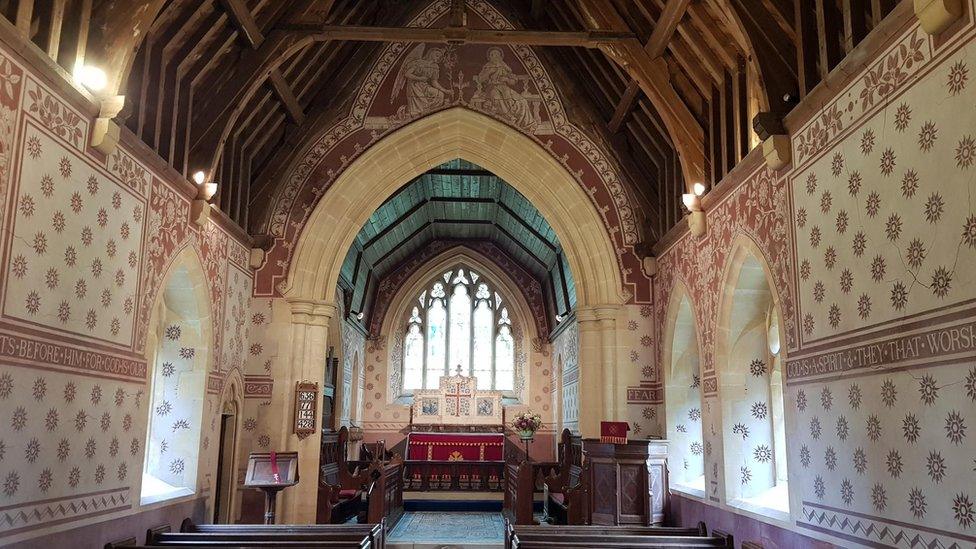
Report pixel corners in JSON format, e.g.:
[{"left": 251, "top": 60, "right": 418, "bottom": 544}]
[{"left": 272, "top": 298, "right": 337, "bottom": 524}]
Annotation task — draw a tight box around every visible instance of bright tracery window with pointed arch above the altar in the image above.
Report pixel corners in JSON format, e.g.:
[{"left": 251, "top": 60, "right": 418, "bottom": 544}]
[{"left": 403, "top": 267, "right": 515, "bottom": 393}]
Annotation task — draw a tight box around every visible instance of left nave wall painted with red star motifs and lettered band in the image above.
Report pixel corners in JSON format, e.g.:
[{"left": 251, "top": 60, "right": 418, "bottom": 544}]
[{"left": 0, "top": 35, "right": 253, "bottom": 544}]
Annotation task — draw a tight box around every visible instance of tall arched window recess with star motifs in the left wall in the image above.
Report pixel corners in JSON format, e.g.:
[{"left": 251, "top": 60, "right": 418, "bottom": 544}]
[{"left": 140, "top": 246, "right": 213, "bottom": 505}]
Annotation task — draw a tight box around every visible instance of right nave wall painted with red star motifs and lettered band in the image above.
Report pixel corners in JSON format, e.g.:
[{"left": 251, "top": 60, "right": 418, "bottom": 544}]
[{"left": 655, "top": 6, "right": 976, "bottom": 547}]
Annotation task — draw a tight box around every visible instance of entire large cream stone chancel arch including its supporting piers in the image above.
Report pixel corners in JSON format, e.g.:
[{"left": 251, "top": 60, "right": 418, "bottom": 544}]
[{"left": 274, "top": 107, "right": 626, "bottom": 523}]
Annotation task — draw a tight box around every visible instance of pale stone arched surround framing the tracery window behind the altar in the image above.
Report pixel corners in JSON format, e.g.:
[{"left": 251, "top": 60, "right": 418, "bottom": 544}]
[{"left": 380, "top": 245, "right": 540, "bottom": 403}]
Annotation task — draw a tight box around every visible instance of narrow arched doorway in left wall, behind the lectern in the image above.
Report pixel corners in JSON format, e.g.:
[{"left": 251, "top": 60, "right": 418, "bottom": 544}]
[{"left": 211, "top": 367, "right": 244, "bottom": 524}]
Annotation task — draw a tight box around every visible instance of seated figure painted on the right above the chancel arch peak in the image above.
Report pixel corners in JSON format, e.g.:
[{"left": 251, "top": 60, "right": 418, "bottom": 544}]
[{"left": 472, "top": 47, "right": 538, "bottom": 128}]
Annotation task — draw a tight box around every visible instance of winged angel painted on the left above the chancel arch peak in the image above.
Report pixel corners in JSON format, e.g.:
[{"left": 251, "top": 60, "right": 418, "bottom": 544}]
[{"left": 390, "top": 44, "right": 451, "bottom": 117}]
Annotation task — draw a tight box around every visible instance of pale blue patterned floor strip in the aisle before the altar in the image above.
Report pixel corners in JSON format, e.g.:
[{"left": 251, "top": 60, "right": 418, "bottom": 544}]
[{"left": 387, "top": 511, "right": 505, "bottom": 549}]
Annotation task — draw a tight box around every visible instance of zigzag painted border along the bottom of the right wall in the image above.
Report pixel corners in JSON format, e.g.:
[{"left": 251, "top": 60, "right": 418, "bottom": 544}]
[{"left": 797, "top": 502, "right": 974, "bottom": 549}]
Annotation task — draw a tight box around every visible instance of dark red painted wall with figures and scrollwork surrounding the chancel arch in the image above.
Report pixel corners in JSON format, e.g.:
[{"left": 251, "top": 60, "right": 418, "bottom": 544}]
[{"left": 256, "top": 0, "right": 651, "bottom": 303}]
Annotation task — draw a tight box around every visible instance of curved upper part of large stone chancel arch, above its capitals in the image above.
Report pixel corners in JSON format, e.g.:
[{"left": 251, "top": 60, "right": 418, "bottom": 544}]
[{"left": 283, "top": 107, "right": 625, "bottom": 307}]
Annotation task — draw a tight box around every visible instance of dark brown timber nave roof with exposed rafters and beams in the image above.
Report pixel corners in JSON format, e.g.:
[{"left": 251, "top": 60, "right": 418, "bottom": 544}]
[{"left": 9, "top": 0, "right": 907, "bottom": 247}]
